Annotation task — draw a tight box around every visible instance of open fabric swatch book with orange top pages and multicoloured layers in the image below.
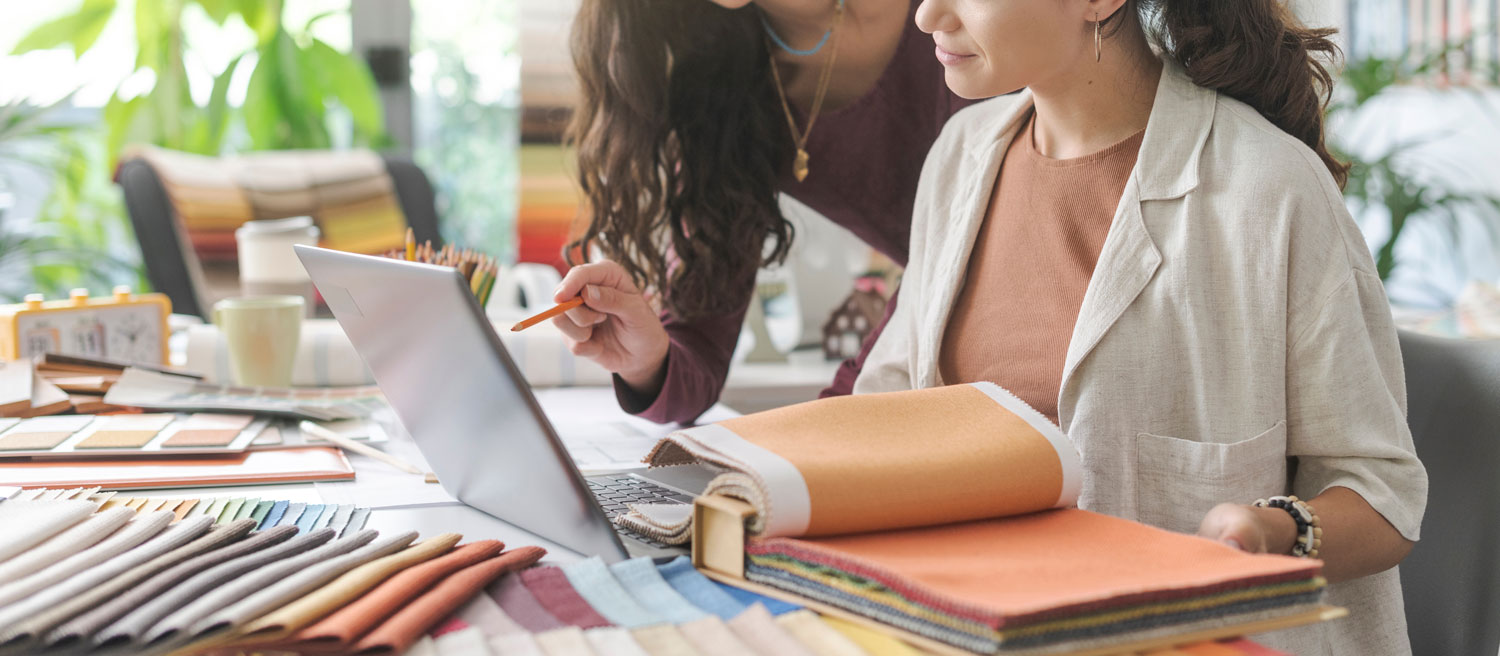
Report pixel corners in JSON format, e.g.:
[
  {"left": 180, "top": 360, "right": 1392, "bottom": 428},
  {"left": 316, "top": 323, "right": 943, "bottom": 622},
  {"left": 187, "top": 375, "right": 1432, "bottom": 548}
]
[{"left": 618, "top": 383, "right": 1325, "bottom": 653}]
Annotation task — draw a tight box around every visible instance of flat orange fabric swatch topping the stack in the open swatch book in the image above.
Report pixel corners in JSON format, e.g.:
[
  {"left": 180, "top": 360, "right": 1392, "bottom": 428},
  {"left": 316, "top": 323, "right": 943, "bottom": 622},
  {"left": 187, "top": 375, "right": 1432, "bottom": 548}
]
[{"left": 747, "top": 509, "right": 1322, "bottom": 626}]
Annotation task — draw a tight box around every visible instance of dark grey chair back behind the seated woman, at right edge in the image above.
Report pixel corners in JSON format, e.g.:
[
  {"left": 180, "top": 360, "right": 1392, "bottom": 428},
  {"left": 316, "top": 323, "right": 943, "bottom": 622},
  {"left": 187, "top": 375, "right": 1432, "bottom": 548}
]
[{"left": 1400, "top": 332, "right": 1500, "bottom": 656}]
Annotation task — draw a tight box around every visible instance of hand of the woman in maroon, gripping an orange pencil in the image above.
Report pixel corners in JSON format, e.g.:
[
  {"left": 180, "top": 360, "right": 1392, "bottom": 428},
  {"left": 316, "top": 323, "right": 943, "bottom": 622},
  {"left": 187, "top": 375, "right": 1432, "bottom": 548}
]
[{"left": 543, "top": 261, "right": 671, "bottom": 398}]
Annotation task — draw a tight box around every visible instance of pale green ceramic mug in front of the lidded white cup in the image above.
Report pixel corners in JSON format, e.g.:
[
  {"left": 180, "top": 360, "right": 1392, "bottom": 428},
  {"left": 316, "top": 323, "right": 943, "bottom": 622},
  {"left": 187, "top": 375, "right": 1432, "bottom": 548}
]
[{"left": 213, "top": 296, "right": 303, "bottom": 387}]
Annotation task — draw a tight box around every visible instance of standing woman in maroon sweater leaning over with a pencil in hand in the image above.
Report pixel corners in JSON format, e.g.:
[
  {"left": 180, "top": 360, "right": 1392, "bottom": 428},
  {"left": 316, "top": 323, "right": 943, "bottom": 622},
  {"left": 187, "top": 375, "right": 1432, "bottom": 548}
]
[{"left": 555, "top": 0, "right": 969, "bottom": 422}]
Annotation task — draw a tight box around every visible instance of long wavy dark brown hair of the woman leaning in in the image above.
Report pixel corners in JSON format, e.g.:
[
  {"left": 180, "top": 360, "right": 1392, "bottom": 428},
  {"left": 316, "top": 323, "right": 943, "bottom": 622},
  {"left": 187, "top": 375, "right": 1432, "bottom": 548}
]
[{"left": 567, "top": 0, "right": 792, "bottom": 318}]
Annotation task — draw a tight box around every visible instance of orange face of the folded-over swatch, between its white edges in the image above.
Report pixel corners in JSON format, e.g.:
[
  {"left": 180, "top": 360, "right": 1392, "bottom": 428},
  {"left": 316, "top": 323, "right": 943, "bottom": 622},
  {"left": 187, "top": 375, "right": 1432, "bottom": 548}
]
[{"left": 720, "top": 386, "right": 1062, "bottom": 536}]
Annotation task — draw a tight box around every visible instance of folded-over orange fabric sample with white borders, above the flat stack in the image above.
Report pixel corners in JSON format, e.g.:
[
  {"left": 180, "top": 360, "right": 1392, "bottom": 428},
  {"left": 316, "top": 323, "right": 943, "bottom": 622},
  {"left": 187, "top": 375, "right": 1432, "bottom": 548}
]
[{"left": 617, "top": 383, "right": 1083, "bottom": 543}]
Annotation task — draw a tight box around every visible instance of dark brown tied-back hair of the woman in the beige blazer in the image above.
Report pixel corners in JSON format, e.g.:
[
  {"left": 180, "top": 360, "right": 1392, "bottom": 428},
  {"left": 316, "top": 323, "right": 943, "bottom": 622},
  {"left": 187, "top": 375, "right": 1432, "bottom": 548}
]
[{"left": 1112, "top": 0, "right": 1349, "bottom": 188}]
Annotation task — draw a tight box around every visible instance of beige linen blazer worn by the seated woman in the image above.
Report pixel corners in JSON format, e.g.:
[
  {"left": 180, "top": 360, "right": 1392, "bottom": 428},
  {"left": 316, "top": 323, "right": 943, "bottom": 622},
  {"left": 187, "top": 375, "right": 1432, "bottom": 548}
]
[{"left": 855, "top": 63, "right": 1427, "bottom": 656}]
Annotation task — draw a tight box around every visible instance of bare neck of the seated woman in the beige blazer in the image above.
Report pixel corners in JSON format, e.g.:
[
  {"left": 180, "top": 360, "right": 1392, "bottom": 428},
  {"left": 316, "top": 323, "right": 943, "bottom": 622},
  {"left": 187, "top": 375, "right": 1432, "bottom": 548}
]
[{"left": 1031, "top": 24, "right": 1163, "bottom": 159}]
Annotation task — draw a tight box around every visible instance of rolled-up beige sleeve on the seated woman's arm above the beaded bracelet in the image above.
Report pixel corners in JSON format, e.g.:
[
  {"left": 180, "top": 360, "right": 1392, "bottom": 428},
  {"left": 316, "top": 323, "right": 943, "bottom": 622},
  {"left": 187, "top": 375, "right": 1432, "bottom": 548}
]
[{"left": 1287, "top": 269, "right": 1427, "bottom": 540}]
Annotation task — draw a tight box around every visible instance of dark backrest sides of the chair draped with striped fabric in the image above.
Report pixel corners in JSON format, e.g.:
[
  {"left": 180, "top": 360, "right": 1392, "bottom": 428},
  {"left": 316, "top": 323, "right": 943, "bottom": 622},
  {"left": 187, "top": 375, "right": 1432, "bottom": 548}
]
[{"left": 116, "top": 155, "right": 443, "bottom": 318}]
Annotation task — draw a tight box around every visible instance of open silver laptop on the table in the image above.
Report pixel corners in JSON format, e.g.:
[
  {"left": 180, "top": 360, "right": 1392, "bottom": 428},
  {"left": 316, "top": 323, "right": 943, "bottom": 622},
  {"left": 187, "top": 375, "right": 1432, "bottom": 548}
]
[{"left": 296, "top": 246, "right": 711, "bottom": 561}]
